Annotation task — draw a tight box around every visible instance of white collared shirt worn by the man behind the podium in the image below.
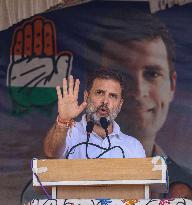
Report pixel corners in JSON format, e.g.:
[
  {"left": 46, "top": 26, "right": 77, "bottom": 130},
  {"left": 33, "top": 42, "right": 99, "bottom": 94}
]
[{"left": 62, "top": 115, "right": 145, "bottom": 159}]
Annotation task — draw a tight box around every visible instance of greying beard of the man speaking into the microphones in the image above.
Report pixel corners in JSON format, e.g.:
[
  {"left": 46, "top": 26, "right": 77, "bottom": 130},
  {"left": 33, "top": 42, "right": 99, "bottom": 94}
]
[{"left": 85, "top": 98, "right": 121, "bottom": 126}]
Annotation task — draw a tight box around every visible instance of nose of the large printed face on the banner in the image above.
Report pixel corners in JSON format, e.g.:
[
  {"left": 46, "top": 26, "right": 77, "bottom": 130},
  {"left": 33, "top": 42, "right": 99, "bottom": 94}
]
[{"left": 128, "top": 77, "right": 150, "bottom": 98}]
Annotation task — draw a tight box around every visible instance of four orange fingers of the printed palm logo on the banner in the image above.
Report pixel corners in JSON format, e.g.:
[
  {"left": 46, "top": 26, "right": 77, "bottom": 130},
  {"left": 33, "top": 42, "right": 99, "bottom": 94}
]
[{"left": 12, "top": 16, "right": 56, "bottom": 62}]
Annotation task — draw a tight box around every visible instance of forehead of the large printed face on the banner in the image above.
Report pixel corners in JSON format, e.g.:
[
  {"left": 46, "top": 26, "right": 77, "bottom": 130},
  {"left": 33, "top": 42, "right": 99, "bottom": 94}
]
[{"left": 101, "top": 38, "right": 169, "bottom": 70}]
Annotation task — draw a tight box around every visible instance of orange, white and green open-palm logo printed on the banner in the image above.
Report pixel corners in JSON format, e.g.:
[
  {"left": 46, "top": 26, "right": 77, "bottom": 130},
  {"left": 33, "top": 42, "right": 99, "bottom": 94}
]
[{"left": 7, "top": 16, "right": 73, "bottom": 111}]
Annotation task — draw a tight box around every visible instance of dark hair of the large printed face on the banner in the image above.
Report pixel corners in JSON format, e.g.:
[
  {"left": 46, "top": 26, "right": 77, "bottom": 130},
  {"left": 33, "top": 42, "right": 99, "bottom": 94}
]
[{"left": 100, "top": 8, "right": 176, "bottom": 73}]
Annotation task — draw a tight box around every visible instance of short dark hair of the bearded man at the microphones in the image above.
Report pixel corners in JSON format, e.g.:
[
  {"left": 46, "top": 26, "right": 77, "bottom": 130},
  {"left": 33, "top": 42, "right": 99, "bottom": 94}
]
[{"left": 86, "top": 68, "right": 126, "bottom": 98}]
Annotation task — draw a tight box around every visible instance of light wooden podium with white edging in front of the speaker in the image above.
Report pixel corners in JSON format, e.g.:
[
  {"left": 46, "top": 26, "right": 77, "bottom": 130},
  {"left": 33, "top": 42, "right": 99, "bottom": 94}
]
[{"left": 33, "top": 157, "right": 167, "bottom": 199}]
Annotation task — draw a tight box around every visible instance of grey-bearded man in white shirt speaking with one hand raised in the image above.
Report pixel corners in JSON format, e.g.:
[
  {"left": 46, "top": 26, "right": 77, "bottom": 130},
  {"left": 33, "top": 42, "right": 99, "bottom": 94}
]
[{"left": 44, "top": 69, "right": 145, "bottom": 159}]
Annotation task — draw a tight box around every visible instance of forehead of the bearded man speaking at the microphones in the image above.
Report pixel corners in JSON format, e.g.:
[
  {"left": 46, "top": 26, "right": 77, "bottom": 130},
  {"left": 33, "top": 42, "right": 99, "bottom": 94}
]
[{"left": 91, "top": 78, "right": 121, "bottom": 93}]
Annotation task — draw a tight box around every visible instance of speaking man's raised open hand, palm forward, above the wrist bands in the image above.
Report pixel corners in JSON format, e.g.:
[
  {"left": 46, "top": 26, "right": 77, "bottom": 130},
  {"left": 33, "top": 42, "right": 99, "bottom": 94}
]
[{"left": 56, "top": 75, "right": 87, "bottom": 120}]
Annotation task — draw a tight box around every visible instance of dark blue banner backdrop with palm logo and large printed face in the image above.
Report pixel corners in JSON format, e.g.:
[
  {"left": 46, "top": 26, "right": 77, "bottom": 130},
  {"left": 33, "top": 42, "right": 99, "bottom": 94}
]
[{"left": 0, "top": 2, "right": 192, "bottom": 204}]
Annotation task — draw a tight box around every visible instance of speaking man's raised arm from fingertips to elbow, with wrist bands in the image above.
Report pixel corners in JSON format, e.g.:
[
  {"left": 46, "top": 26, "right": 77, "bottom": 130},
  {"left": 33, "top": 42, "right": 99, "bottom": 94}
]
[{"left": 44, "top": 75, "right": 87, "bottom": 158}]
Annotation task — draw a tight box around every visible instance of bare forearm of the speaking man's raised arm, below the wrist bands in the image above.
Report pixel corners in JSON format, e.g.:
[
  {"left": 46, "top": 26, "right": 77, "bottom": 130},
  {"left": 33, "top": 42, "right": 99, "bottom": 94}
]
[{"left": 44, "top": 123, "right": 68, "bottom": 158}]
